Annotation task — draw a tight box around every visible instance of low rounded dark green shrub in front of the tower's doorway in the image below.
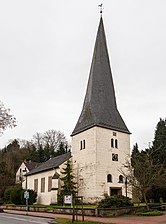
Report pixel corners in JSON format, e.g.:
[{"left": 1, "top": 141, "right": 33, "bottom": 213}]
[{"left": 98, "top": 195, "right": 133, "bottom": 208}]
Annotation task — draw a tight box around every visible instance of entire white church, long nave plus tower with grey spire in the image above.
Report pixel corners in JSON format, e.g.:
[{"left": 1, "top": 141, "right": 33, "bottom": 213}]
[{"left": 19, "top": 14, "right": 131, "bottom": 205}]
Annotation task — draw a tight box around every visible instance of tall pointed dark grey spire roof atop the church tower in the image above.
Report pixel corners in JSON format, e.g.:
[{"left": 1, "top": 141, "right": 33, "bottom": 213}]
[{"left": 72, "top": 17, "right": 130, "bottom": 136}]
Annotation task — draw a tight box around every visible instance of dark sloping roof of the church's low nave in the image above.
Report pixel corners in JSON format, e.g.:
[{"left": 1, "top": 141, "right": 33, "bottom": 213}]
[{"left": 26, "top": 152, "right": 71, "bottom": 176}]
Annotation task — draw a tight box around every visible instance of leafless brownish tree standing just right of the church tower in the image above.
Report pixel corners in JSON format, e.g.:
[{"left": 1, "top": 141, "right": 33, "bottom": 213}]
[{"left": 121, "top": 151, "right": 166, "bottom": 209}]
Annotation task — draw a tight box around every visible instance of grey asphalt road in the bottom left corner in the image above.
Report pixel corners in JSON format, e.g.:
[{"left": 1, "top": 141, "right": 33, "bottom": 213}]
[{"left": 0, "top": 213, "right": 52, "bottom": 224}]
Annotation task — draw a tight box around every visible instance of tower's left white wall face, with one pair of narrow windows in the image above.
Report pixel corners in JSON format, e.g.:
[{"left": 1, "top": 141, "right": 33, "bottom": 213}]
[{"left": 72, "top": 128, "right": 97, "bottom": 202}]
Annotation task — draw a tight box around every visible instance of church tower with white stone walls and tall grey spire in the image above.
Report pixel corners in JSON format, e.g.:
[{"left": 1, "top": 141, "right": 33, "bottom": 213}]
[{"left": 71, "top": 16, "right": 130, "bottom": 203}]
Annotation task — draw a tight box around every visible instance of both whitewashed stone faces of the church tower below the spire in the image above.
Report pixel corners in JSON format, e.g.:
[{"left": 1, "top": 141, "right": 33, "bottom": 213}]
[{"left": 72, "top": 127, "right": 130, "bottom": 203}]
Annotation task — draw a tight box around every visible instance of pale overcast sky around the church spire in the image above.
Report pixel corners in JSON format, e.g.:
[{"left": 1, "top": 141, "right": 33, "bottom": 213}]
[{"left": 0, "top": 0, "right": 166, "bottom": 149}]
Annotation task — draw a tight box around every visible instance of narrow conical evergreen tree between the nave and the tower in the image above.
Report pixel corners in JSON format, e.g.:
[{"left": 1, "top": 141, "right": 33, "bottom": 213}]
[{"left": 58, "top": 160, "right": 77, "bottom": 204}]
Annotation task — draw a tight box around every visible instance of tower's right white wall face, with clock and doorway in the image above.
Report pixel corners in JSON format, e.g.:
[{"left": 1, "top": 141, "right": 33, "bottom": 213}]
[{"left": 96, "top": 127, "right": 130, "bottom": 198}]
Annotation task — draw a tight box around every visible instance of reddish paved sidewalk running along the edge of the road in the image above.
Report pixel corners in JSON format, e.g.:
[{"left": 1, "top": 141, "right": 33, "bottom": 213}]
[{"left": 4, "top": 210, "right": 166, "bottom": 224}]
